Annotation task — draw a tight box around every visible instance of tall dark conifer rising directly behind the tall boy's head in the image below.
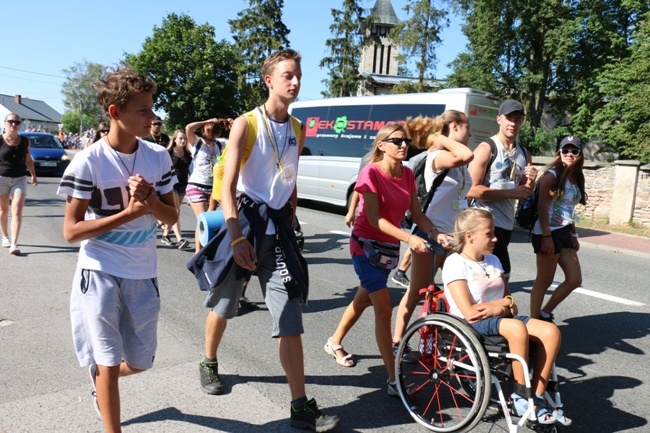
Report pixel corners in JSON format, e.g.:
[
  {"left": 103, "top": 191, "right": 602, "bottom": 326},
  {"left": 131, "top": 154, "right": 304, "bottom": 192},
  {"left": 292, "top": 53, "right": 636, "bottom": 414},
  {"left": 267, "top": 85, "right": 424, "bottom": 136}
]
[{"left": 228, "top": 0, "right": 289, "bottom": 107}]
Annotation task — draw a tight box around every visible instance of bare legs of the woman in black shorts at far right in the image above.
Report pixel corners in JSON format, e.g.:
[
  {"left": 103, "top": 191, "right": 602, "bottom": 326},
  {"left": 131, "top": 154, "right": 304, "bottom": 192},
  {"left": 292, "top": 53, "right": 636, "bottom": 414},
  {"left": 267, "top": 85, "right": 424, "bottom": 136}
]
[{"left": 530, "top": 248, "right": 582, "bottom": 318}]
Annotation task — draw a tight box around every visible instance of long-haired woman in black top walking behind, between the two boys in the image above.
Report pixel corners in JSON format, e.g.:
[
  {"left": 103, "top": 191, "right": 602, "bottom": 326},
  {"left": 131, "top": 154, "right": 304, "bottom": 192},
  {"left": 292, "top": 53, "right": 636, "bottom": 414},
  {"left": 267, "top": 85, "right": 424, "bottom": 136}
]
[{"left": 160, "top": 129, "right": 192, "bottom": 250}]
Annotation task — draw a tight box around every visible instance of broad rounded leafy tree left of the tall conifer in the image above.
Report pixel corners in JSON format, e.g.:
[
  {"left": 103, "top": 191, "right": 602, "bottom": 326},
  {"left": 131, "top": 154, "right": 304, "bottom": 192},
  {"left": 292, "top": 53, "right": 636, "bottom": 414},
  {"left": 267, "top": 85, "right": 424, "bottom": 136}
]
[{"left": 126, "top": 13, "right": 242, "bottom": 128}]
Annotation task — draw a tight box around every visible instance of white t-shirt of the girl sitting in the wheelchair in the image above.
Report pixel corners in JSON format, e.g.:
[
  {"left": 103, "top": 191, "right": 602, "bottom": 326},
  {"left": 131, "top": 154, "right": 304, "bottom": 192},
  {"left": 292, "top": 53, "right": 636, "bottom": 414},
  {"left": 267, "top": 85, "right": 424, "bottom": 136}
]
[{"left": 442, "top": 253, "right": 505, "bottom": 318}]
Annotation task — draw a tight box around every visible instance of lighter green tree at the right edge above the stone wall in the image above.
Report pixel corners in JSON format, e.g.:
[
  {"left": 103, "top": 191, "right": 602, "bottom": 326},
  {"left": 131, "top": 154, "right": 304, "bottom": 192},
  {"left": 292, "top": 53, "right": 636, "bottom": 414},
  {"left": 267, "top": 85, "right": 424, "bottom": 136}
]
[{"left": 589, "top": 12, "right": 650, "bottom": 163}]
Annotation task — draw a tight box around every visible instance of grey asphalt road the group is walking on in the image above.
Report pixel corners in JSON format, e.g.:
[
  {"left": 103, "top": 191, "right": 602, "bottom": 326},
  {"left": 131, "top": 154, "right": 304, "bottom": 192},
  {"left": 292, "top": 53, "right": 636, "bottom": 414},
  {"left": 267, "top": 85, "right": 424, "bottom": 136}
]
[{"left": 0, "top": 178, "right": 650, "bottom": 433}]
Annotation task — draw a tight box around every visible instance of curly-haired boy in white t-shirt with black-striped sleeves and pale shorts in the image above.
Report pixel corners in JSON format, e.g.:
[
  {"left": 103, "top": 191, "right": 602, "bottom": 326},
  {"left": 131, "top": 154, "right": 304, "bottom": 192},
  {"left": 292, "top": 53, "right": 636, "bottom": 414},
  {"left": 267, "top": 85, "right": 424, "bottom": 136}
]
[{"left": 57, "top": 69, "right": 177, "bottom": 432}]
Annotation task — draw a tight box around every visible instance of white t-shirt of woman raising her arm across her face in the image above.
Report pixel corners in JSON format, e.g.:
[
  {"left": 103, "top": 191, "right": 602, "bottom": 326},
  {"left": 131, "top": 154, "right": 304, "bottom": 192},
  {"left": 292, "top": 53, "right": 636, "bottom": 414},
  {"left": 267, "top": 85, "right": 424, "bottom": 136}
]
[{"left": 424, "top": 149, "right": 472, "bottom": 234}]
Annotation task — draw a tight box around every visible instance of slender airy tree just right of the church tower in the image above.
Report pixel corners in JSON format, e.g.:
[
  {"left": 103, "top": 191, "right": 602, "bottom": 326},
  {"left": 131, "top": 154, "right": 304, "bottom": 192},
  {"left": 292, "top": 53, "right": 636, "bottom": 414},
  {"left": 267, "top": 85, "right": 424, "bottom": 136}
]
[{"left": 390, "top": 0, "right": 449, "bottom": 87}]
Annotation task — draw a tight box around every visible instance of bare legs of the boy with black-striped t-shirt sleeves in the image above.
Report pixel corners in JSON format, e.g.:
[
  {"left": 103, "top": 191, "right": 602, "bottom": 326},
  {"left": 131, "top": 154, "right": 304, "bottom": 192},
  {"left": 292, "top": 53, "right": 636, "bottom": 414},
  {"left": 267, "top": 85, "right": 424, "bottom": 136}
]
[{"left": 95, "top": 361, "right": 144, "bottom": 433}]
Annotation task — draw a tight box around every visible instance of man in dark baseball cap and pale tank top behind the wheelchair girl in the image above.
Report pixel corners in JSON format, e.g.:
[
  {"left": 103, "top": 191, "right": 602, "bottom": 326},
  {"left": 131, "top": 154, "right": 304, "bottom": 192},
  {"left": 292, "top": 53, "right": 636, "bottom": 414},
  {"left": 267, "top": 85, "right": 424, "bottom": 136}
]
[{"left": 467, "top": 99, "right": 537, "bottom": 281}]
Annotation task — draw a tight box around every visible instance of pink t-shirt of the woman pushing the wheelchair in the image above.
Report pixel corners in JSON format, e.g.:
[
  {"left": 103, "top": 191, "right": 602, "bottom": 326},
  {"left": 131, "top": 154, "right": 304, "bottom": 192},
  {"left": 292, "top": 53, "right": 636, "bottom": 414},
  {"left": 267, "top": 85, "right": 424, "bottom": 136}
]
[{"left": 350, "top": 163, "right": 415, "bottom": 255}]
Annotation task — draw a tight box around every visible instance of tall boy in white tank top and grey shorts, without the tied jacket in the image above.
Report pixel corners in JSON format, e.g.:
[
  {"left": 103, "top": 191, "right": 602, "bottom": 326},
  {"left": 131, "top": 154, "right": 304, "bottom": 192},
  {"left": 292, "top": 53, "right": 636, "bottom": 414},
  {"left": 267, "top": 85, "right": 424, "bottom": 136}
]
[{"left": 199, "top": 49, "right": 339, "bottom": 432}]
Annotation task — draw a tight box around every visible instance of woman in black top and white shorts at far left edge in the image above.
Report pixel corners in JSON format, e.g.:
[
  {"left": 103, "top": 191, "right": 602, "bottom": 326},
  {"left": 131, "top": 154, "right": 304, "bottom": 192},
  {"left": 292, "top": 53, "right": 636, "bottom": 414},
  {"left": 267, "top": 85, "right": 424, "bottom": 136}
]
[{"left": 0, "top": 113, "right": 38, "bottom": 255}]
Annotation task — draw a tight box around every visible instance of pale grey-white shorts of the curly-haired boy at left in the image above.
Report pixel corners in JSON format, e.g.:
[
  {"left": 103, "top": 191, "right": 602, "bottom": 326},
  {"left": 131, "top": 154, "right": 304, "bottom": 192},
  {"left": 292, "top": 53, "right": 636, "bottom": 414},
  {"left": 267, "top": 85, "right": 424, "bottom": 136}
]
[{"left": 70, "top": 268, "right": 160, "bottom": 370}]
